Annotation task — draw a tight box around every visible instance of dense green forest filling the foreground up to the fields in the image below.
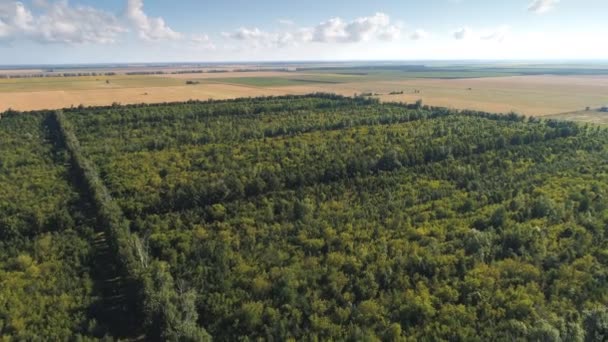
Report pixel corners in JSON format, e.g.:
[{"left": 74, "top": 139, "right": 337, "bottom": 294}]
[{"left": 0, "top": 94, "right": 608, "bottom": 341}]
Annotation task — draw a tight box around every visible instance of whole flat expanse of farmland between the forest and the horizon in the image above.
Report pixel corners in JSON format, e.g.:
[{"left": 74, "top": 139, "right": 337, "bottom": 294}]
[{"left": 0, "top": 65, "right": 608, "bottom": 121}]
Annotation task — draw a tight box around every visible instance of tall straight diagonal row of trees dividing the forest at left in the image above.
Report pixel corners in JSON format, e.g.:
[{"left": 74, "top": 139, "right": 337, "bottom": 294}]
[{"left": 54, "top": 111, "right": 210, "bottom": 341}]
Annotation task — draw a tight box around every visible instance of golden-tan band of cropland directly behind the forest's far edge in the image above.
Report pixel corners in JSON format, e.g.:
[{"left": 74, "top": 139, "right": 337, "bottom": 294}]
[{"left": 0, "top": 72, "right": 608, "bottom": 116}]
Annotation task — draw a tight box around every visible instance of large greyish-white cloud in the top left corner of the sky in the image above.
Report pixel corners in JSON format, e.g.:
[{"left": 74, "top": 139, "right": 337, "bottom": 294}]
[{"left": 0, "top": 0, "right": 126, "bottom": 44}]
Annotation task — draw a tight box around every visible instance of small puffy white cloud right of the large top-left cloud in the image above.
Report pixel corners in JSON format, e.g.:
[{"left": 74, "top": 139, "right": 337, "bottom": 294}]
[{"left": 126, "top": 0, "right": 182, "bottom": 41}]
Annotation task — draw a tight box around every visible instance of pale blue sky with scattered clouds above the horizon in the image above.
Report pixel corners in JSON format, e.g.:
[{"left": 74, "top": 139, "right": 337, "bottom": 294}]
[{"left": 0, "top": 0, "right": 608, "bottom": 65}]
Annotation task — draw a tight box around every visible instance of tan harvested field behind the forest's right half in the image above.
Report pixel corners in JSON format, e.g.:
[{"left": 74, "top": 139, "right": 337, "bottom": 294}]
[{"left": 280, "top": 76, "right": 608, "bottom": 116}]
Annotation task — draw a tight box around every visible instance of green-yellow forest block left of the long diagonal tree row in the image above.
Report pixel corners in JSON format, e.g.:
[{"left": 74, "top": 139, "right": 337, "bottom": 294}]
[{"left": 0, "top": 113, "right": 98, "bottom": 340}]
